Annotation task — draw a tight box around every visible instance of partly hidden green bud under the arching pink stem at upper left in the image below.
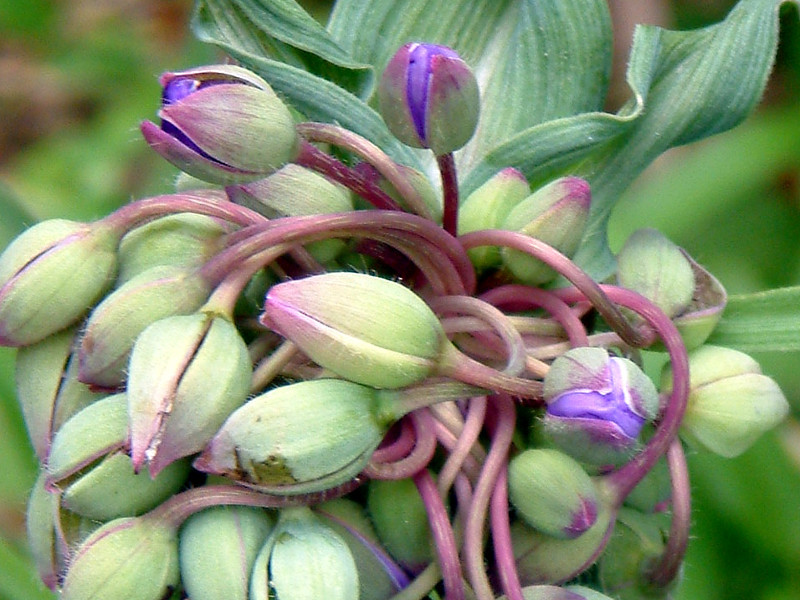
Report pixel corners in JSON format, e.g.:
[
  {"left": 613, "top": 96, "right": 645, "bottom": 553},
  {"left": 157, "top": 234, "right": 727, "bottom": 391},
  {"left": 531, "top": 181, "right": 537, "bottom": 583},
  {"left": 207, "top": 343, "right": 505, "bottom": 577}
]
[{"left": 117, "top": 213, "right": 226, "bottom": 283}]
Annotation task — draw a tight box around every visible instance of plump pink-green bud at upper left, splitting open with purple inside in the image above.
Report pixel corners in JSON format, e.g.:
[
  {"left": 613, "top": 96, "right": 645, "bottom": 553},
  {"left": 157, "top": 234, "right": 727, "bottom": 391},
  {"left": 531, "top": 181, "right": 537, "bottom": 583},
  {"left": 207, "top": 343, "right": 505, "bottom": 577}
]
[{"left": 142, "top": 65, "right": 299, "bottom": 184}]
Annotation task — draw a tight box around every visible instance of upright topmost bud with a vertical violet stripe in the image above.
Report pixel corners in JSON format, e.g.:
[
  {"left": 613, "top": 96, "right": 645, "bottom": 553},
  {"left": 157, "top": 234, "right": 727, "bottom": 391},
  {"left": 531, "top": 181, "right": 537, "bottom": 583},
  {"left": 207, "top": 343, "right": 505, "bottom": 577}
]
[{"left": 378, "top": 43, "right": 480, "bottom": 155}]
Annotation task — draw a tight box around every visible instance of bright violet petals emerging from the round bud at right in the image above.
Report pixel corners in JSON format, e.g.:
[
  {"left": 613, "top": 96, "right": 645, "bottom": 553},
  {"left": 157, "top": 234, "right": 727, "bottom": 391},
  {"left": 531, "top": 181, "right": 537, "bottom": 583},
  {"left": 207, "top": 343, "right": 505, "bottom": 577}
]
[{"left": 547, "top": 357, "right": 645, "bottom": 438}]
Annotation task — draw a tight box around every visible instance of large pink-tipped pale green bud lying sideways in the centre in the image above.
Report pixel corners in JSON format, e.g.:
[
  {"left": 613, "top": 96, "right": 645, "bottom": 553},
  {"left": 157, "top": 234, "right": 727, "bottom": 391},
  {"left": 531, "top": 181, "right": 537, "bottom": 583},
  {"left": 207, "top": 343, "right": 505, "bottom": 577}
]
[{"left": 261, "top": 272, "right": 445, "bottom": 388}]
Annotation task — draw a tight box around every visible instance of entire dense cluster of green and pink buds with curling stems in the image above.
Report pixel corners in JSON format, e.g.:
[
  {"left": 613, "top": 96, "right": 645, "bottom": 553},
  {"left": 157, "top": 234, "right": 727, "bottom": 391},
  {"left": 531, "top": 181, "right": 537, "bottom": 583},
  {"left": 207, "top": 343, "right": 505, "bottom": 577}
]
[{"left": 0, "top": 43, "right": 787, "bottom": 600}]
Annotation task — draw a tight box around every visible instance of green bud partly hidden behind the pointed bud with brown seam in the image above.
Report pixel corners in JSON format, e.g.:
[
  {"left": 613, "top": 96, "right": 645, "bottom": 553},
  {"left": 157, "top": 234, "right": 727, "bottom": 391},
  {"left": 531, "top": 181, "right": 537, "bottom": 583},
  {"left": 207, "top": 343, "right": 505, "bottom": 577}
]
[{"left": 80, "top": 265, "right": 210, "bottom": 388}]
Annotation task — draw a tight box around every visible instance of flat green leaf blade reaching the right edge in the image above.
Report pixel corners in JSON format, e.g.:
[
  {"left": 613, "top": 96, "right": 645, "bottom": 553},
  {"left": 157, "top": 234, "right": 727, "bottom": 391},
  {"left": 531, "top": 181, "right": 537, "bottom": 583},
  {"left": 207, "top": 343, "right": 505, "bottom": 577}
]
[{"left": 708, "top": 286, "right": 800, "bottom": 352}]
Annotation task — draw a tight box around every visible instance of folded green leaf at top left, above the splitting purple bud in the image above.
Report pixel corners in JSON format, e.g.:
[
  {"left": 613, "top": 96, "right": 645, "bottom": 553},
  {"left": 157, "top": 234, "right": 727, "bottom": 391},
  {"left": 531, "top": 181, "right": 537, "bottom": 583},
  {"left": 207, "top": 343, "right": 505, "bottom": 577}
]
[{"left": 193, "top": 0, "right": 374, "bottom": 95}]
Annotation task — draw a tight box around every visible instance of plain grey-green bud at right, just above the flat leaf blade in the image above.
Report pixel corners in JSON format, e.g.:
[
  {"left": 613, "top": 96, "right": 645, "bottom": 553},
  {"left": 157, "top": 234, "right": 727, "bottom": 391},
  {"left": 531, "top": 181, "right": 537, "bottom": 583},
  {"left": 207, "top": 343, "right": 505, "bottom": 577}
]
[{"left": 617, "top": 229, "right": 695, "bottom": 317}]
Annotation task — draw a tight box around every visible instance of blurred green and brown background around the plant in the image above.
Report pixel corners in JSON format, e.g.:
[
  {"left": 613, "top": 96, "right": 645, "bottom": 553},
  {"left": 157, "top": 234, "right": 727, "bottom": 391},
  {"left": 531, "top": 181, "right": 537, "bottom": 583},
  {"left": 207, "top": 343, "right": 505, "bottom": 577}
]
[{"left": 0, "top": 0, "right": 800, "bottom": 600}]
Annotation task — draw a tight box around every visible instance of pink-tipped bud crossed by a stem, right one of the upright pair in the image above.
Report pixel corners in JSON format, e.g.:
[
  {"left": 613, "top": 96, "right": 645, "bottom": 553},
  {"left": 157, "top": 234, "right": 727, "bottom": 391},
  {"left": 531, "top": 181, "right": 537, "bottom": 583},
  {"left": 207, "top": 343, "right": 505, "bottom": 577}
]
[{"left": 500, "top": 177, "right": 591, "bottom": 285}]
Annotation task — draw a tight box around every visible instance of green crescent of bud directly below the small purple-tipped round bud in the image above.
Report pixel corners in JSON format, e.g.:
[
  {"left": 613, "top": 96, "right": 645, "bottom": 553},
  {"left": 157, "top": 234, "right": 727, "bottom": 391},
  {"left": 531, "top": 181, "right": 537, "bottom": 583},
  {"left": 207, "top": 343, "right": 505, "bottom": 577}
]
[{"left": 511, "top": 502, "right": 613, "bottom": 585}]
